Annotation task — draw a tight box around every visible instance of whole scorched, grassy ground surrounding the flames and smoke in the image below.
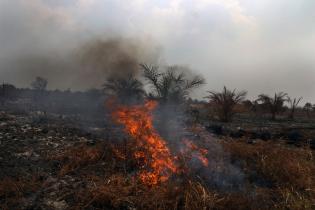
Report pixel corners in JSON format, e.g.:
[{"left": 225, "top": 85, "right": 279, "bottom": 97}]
[{"left": 0, "top": 112, "right": 315, "bottom": 210}]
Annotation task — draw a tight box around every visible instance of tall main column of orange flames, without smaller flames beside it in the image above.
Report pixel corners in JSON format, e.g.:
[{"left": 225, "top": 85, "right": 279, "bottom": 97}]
[{"left": 113, "top": 101, "right": 178, "bottom": 185}]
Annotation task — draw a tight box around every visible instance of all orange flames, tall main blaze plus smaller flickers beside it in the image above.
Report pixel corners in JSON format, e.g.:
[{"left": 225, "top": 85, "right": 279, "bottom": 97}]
[{"left": 112, "top": 101, "right": 209, "bottom": 186}]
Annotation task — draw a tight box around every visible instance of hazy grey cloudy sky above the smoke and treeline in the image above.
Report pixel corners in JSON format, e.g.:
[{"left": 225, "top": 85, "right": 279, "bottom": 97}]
[{"left": 0, "top": 0, "right": 315, "bottom": 103}]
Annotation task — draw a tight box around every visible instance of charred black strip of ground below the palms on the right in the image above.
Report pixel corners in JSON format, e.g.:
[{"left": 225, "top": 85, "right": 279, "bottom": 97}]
[{"left": 203, "top": 115, "right": 315, "bottom": 149}]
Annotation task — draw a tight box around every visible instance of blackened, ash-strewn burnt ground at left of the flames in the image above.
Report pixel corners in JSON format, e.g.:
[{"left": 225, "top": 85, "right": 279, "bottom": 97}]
[{"left": 0, "top": 112, "right": 115, "bottom": 209}]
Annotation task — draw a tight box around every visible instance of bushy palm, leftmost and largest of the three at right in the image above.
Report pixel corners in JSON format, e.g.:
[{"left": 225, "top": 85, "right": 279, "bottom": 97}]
[{"left": 205, "top": 86, "right": 247, "bottom": 122}]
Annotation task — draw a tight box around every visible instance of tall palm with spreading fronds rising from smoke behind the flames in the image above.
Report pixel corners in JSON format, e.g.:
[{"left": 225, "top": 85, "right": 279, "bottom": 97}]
[{"left": 141, "top": 64, "right": 205, "bottom": 141}]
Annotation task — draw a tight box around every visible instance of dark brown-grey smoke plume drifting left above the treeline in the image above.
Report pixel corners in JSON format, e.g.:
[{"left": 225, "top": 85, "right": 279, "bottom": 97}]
[{"left": 0, "top": 38, "right": 158, "bottom": 89}]
